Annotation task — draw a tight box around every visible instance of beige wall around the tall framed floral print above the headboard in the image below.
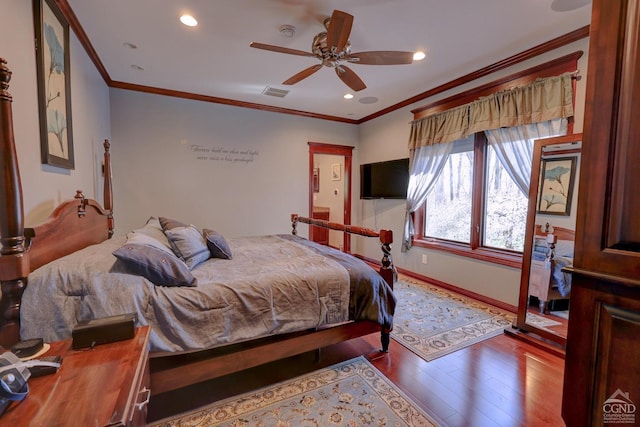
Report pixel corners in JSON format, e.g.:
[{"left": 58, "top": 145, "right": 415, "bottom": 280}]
[{"left": 0, "top": 0, "right": 110, "bottom": 226}]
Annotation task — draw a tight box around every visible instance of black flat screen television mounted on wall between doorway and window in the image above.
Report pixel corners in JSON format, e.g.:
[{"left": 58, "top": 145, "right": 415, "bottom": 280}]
[{"left": 360, "top": 158, "right": 409, "bottom": 199}]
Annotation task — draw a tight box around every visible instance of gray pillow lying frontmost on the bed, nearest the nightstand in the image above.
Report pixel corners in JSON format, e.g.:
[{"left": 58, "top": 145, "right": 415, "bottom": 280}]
[{"left": 113, "top": 243, "right": 196, "bottom": 286}]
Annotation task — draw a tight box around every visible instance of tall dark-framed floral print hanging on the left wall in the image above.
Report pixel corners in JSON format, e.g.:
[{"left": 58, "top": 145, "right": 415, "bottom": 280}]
[{"left": 33, "top": 0, "right": 74, "bottom": 169}]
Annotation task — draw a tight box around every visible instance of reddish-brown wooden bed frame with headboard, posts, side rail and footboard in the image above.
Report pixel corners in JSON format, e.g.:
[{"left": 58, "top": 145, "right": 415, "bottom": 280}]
[{"left": 0, "top": 58, "right": 396, "bottom": 395}]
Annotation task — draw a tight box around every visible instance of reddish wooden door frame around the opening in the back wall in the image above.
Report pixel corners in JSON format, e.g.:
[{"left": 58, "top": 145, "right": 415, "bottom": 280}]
[{"left": 308, "top": 141, "right": 354, "bottom": 253}]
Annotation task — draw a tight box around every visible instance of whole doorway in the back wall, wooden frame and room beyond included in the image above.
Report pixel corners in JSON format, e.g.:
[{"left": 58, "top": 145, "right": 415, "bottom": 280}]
[{"left": 309, "top": 142, "right": 353, "bottom": 252}]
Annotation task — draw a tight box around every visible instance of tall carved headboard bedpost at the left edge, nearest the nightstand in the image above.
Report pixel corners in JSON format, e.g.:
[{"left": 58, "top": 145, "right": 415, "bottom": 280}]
[{"left": 0, "top": 58, "right": 29, "bottom": 347}]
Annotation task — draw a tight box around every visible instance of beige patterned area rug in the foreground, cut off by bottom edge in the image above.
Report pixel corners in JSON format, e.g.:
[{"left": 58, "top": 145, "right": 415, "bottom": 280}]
[{"left": 149, "top": 356, "right": 438, "bottom": 427}]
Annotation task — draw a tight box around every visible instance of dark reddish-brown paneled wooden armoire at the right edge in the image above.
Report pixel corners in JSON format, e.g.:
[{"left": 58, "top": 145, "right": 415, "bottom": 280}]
[{"left": 562, "top": 0, "right": 640, "bottom": 427}]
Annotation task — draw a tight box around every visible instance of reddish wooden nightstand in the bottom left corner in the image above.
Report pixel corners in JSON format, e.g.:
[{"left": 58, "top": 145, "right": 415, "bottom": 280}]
[{"left": 0, "top": 326, "right": 151, "bottom": 426}]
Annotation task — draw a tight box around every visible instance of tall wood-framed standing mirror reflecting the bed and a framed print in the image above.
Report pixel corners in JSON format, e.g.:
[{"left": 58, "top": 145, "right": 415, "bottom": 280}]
[{"left": 514, "top": 134, "right": 582, "bottom": 347}]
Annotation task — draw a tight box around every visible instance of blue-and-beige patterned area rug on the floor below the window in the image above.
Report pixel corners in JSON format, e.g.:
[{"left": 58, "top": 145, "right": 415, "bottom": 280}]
[{"left": 391, "top": 276, "right": 515, "bottom": 361}]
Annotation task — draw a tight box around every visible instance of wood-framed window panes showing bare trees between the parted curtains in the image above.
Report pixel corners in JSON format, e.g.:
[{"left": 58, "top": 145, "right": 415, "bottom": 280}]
[{"left": 414, "top": 133, "right": 528, "bottom": 265}]
